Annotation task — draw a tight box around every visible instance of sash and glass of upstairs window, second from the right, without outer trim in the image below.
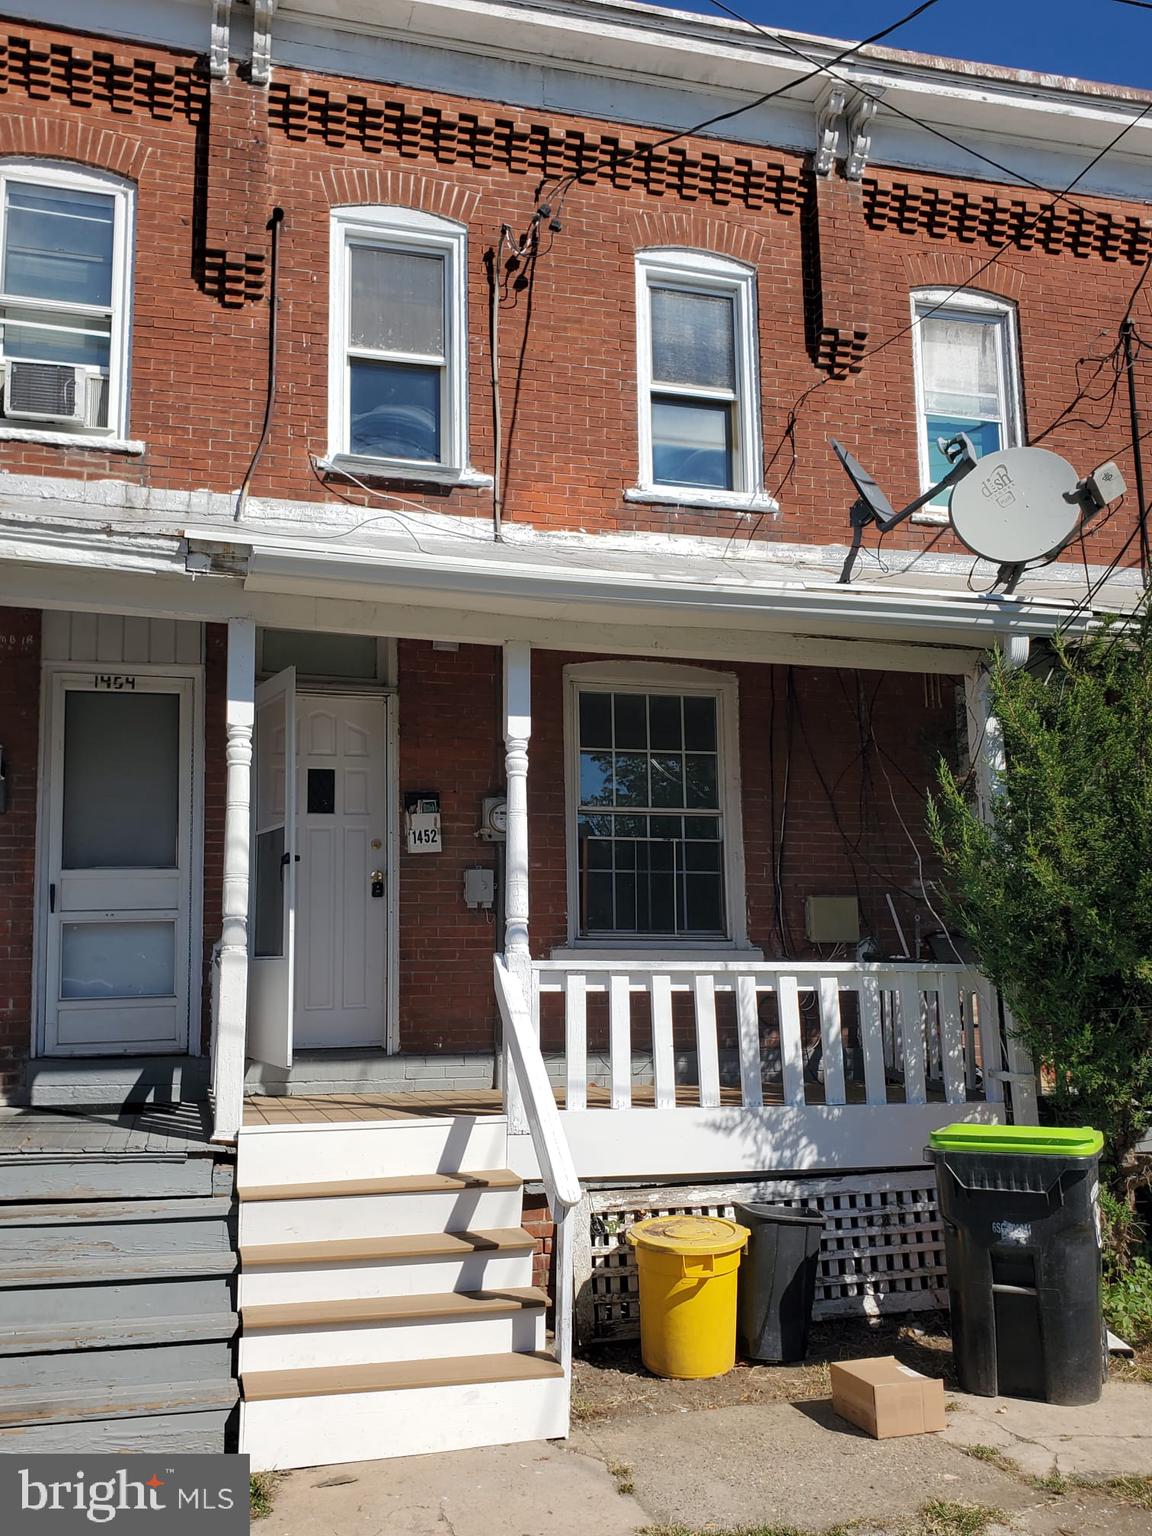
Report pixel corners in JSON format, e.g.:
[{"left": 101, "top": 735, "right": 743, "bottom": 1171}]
[{"left": 648, "top": 276, "right": 740, "bottom": 490}]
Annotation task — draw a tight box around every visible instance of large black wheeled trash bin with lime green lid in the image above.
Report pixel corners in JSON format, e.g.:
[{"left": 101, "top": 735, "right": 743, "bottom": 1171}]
[{"left": 926, "top": 1124, "right": 1107, "bottom": 1407}]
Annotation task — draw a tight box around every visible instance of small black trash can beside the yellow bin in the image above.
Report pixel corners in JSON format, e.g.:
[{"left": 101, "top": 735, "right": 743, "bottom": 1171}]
[{"left": 736, "top": 1204, "right": 823, "bottom": 1364}]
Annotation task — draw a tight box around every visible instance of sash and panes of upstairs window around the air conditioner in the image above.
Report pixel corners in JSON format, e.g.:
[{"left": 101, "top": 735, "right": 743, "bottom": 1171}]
[{"left": 0, "top": 174, "right": 117, "bottom": 427}]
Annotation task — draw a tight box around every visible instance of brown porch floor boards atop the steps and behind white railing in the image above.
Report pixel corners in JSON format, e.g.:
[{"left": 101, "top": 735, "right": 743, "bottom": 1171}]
[{"left": 244, "top": 1083, "right": 945, "bottom": 1126}]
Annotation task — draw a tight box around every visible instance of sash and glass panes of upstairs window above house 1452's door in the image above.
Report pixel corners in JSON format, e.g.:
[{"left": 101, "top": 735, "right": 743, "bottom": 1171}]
[{"left": 347, "top": 240, "right": 450, "bottom": 464}]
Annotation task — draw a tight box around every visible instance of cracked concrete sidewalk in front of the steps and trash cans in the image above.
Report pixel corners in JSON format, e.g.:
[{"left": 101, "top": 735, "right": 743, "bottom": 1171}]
[{"left": 253, "top": 1382, "right": 1152, "bottom": 1536}]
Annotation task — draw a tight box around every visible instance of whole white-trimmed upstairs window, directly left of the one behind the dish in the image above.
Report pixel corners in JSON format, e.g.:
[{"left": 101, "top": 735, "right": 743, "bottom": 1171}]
[{"left": 636, "top": 250, "right": 763, "bottom": 499}]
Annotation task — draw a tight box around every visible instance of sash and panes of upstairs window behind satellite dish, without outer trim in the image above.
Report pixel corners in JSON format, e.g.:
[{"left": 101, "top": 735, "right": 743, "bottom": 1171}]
[{"left": 917, "top": 303, "right": 1015, "bottom": 504}]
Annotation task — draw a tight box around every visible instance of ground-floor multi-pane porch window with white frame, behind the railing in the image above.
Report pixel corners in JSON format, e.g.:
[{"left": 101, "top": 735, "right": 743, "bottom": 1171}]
[{"left": 568, "top": 664, "right": 745, "bottom": 946}]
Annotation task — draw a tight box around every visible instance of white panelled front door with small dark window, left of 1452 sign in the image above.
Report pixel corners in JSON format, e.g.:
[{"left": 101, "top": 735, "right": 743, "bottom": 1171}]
[{"left": 295, "top": 693, "right": 389, "bottom": 1049}]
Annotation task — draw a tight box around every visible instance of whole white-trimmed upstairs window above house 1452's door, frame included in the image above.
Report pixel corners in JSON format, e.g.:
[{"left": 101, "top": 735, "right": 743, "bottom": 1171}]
[{"left": 329, "top": 207, "right": 467, "bottom": 476}]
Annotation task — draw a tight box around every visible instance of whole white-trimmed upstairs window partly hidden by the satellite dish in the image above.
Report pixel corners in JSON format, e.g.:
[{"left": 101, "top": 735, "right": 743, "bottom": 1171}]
[{"left": 912, "top": 289, "right": 1021, "bottom": 502}]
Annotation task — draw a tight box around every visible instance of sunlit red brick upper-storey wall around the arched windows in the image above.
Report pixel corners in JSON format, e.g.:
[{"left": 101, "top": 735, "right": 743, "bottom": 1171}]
[{"left": 0, "top": 23, "right": 1152, "bottom": 577}]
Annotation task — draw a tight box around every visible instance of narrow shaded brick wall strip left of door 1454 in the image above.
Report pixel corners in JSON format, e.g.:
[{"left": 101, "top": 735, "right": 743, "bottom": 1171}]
[{"left": 0, "top": 608, "right": 40, "bottom": 1103}]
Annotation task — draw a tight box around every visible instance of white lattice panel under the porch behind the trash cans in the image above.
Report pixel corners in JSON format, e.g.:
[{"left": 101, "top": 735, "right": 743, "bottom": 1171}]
[{"left": 576, "top": 1169, "right": 948, "bottom": 1342}]
